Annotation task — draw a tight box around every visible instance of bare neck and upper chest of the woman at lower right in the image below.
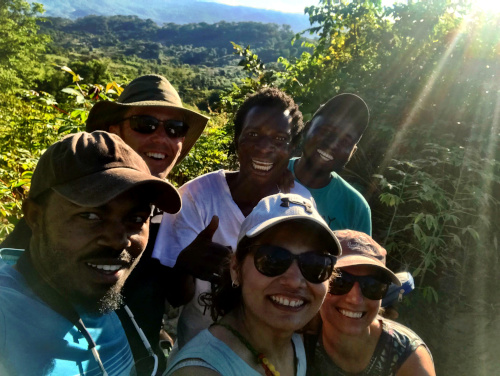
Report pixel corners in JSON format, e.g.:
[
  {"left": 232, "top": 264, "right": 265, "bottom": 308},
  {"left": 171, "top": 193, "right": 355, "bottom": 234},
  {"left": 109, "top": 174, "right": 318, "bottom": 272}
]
[{"left": 321, "top": 320, "right": 381, "bottom": 373}]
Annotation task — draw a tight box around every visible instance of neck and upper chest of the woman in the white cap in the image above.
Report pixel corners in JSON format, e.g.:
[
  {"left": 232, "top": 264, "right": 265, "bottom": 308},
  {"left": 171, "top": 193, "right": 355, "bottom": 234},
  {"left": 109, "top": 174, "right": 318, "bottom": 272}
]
[{"left": 221, "top": 309, "right": 296, "bottom": 375}]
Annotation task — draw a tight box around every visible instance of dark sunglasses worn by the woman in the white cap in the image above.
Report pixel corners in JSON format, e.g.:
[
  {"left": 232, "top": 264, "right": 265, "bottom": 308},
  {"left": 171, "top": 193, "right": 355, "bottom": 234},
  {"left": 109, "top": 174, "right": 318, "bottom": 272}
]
[{"left": 254, "top": 244, "right": 337, "bottom": 283}]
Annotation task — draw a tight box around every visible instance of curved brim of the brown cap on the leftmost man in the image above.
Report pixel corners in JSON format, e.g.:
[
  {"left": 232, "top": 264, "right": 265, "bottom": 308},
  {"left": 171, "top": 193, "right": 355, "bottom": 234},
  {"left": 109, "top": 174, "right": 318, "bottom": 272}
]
[{"left": 52, "top": 167, "right": 182, "bottom": 214}]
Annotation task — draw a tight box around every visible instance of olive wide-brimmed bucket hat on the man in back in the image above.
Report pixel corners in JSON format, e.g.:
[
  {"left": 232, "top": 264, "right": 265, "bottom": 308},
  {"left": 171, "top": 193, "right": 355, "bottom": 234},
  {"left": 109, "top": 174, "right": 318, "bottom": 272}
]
[{"left": 85, "top": 74, "right": 209, "bottom": 164}]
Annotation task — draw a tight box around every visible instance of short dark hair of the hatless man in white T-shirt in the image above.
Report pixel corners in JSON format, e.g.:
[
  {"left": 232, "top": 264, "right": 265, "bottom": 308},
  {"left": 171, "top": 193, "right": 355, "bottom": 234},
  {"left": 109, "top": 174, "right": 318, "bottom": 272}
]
[{"left": 234, "top": 87, "right": 304, "bottom": 148}]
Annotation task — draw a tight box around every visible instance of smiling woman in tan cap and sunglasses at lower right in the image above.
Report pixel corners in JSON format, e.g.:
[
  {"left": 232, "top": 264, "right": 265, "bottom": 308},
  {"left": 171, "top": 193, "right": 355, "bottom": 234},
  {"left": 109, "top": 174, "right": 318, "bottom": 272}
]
[{"left": 307, "top": 230, "right": 435, "bottom": 376}]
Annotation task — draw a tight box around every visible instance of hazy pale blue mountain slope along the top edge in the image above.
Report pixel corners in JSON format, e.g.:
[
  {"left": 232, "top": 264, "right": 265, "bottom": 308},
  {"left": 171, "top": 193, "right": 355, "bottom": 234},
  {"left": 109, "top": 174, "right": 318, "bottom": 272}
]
[{"left": 36, "top": 0, "right": 309, "bottom": 32}]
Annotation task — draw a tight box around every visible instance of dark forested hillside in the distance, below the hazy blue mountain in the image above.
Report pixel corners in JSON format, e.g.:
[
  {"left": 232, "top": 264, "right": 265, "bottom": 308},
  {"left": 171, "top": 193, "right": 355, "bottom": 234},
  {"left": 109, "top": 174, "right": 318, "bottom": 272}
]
[{"left": 40, "top": 16, "right": 306, "bottom": 67}]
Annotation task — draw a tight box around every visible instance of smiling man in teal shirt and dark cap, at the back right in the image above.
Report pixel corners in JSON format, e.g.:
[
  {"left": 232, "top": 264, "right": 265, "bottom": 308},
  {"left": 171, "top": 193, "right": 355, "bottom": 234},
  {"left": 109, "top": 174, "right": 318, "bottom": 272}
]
[{"left": 288, "top": 94, "right": 372, "bottom": 235}]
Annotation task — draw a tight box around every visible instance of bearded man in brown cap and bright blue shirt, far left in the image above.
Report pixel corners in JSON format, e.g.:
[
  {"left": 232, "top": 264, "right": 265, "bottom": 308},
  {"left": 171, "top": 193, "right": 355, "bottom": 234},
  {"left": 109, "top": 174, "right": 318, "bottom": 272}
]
[{"left": 0, "top": 132, "right": 181, "bottom": 375}]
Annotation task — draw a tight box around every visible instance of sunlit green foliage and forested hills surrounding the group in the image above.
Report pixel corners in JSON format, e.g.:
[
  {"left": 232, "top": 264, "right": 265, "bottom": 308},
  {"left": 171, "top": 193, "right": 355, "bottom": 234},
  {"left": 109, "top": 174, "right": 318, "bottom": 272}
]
[{"left": 0, "top": 0, "right": 500, "bottom": 375}]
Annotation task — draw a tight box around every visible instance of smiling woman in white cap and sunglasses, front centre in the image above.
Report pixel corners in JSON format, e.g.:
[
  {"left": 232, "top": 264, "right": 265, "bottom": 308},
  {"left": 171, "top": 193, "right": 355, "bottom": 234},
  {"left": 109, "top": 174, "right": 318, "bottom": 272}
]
[{"left": 167, "top": 194, "right": 340, "bottom": 376}]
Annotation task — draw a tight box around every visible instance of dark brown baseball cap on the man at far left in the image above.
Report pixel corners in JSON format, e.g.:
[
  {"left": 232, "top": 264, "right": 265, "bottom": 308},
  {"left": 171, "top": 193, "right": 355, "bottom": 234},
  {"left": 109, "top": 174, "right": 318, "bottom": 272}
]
[{"left": 28, "top": 131, "right": 181, "bottom": 214}]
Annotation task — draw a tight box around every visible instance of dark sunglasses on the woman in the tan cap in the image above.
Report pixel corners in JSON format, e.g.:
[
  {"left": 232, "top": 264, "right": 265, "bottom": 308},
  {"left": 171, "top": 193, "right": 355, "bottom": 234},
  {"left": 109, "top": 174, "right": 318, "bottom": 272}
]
[{"left": 328, "top": 272, "right": 390, "bottom": 300}]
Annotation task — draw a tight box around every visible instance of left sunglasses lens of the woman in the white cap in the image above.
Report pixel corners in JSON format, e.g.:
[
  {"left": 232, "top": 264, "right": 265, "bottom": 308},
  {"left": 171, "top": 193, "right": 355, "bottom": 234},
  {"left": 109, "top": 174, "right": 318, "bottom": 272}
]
[{"left": 254, "top": 245, "right": 293, "bottom": 277}]
